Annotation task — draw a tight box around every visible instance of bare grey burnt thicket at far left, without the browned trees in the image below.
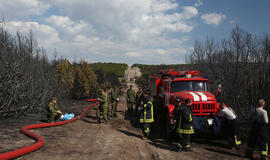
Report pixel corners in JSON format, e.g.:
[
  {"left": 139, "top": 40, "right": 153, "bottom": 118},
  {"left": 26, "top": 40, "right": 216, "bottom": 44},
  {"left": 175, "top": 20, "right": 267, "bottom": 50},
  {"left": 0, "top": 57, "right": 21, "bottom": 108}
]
[{"left": 0, "top": 27, "right": 61, "bottom": 117}]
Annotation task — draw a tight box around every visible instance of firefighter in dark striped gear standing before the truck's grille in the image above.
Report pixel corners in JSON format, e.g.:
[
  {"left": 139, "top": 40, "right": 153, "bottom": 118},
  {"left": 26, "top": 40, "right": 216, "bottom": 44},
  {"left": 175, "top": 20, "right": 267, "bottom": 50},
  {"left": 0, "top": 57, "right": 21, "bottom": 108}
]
[{"left": 176, "top": 99, "right": 194, "bottom": 152}]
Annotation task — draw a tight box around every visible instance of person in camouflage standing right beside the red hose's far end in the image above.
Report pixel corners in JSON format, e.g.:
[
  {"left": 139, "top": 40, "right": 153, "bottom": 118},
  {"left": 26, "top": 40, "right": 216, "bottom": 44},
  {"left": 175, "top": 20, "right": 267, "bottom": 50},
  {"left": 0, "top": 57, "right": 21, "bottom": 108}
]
[{"left": 96, "top": 88, "right": 109, "bottom": 123}]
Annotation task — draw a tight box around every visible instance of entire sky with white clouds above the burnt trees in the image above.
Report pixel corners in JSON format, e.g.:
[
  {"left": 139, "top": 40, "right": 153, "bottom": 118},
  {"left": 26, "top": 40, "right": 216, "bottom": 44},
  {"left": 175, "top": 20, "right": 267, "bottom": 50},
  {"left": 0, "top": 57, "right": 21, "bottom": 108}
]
[{"left": 0, "top": 0, "right": 270, "bottom": 64}]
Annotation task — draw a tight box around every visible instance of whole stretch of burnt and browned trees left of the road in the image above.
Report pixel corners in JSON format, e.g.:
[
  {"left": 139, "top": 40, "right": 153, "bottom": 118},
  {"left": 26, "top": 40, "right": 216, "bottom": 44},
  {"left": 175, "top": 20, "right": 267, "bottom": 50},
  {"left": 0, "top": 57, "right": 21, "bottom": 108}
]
[{"left": 0, "top": 26, "right": 126, "bottom": 117}]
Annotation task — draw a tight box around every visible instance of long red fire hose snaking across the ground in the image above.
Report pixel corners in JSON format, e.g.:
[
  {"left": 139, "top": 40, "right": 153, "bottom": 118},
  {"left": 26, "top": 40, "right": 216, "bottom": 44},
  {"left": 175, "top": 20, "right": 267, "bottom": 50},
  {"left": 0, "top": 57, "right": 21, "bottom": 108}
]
[{"left": 0, "top": 99, "right": 98, "bottom": 160}]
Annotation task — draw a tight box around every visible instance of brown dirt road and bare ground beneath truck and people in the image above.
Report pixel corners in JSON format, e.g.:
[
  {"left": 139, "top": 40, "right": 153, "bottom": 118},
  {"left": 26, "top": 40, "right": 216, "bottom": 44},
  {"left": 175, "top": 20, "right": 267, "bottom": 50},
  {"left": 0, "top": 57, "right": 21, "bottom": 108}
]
[{"left": 0, "top": 67, "right": 266, "bottom": 160}]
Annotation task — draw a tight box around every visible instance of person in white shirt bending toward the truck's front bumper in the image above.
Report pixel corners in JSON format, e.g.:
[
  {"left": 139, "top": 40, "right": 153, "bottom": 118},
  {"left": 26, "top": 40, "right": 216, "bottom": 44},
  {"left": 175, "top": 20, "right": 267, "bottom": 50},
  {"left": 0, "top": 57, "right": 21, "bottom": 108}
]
[{"left": 219, "top": 102, "right": 241, "bottom": 150}]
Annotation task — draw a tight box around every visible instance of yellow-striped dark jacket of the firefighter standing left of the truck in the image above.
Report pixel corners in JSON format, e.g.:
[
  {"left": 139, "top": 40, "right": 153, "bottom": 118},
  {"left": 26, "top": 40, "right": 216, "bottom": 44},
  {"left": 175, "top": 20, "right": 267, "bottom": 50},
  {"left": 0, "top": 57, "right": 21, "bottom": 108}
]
[{"left": 140, "top": 101, "right": 154, "bottom": 123}]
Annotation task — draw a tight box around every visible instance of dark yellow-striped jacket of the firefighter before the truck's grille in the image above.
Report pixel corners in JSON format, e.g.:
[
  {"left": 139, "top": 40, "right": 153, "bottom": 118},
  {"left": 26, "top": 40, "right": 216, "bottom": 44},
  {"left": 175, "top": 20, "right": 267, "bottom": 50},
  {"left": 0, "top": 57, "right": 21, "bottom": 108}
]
[{"left": 176, "top": 105, "right": 194, "bottom": 134}]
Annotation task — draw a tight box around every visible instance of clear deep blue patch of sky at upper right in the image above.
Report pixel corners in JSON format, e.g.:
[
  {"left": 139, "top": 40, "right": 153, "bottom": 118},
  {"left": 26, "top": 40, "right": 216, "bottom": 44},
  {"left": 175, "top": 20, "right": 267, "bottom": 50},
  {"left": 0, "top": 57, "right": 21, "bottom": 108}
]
[{"left": 190, "top": 0, "right": 270, "bottom": 39}]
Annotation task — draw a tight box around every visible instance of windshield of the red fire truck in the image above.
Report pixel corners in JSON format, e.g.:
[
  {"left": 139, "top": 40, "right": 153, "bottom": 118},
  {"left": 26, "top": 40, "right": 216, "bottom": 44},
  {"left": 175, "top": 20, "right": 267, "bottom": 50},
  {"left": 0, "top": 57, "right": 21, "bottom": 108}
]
[{"left": 171, "top": 81, "right": 209, "bottom": 93}]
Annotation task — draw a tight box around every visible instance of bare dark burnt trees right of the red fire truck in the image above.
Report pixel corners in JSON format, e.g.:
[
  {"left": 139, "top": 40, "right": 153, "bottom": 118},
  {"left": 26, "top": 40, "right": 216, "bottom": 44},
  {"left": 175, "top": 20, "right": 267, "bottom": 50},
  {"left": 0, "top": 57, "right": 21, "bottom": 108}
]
[{"left": 187, "top": 26, "right": 270, "bottom": 117}]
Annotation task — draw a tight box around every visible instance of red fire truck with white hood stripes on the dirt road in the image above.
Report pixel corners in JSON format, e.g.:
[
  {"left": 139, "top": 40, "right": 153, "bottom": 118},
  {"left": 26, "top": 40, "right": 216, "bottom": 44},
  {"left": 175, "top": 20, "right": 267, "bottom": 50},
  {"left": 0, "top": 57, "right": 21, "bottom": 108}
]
[{"left": 149, "top": 69, "right": 219, "bottom": 135}]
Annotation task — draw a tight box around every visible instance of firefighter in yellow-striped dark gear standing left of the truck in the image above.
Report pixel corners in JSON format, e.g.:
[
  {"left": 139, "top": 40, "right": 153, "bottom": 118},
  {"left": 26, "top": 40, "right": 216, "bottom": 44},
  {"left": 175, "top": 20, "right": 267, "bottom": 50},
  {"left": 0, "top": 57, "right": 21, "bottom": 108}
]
[{"left": 140, "top": 90, "right": 154, "bottom": 140}]
